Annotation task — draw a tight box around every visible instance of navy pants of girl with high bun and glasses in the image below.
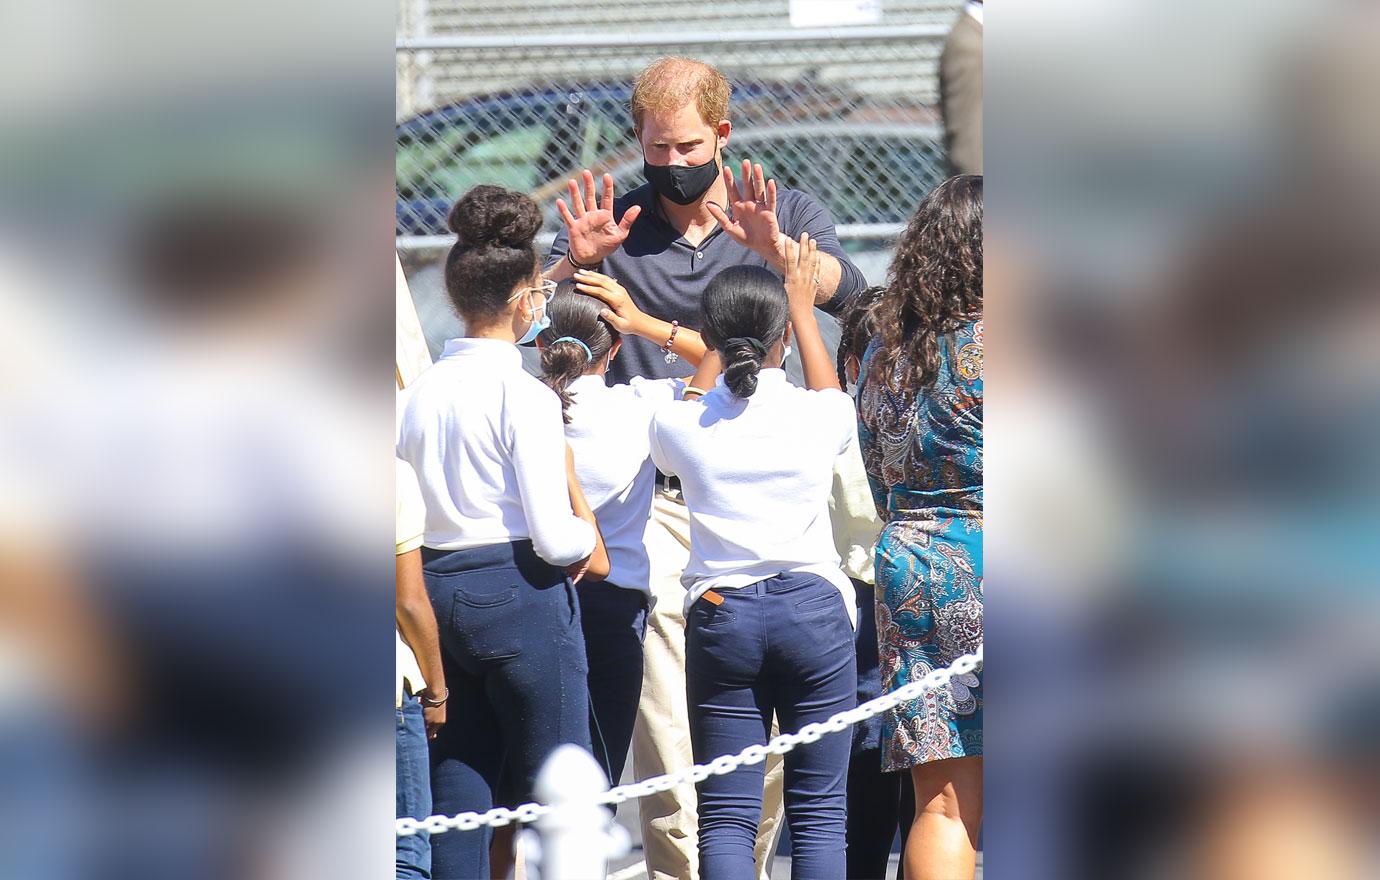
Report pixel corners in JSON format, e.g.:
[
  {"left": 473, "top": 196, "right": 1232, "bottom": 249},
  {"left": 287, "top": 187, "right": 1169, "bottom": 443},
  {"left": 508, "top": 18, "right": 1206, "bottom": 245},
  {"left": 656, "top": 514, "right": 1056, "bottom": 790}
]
[{"left": 422, "top": 541, "right": 589, "bottom": 880}]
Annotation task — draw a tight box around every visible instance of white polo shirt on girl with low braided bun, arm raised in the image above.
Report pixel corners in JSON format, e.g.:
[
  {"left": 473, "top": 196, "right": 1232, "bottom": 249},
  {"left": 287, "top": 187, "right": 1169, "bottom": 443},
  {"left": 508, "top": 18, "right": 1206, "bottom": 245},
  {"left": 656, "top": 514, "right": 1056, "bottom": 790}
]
[{"left": 651, "top": 370, "right": 857, "bottom": 612}]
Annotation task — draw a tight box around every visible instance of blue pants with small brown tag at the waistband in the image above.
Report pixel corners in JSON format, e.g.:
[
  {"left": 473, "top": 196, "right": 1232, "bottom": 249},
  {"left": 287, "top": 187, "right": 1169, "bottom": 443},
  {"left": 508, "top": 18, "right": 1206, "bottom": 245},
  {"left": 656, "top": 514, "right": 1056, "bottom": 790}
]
[{"left": 686, "top": 574, "right": 857, "bottom": 880}]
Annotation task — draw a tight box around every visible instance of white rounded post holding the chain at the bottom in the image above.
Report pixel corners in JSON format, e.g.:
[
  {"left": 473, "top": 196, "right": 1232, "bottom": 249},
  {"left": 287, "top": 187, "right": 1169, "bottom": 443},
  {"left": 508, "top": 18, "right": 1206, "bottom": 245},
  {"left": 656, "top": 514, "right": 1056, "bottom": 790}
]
[{"left": 526, "top": 745, "right": 628, "bottom": 880}]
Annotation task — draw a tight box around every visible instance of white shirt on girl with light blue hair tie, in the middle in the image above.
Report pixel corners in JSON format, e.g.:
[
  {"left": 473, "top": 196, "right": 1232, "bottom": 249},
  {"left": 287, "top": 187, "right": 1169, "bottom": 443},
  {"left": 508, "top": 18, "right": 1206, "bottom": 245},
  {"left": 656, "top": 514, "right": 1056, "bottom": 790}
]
[{"left": 566, "top": 375, "right": 684, "bottom": 594}]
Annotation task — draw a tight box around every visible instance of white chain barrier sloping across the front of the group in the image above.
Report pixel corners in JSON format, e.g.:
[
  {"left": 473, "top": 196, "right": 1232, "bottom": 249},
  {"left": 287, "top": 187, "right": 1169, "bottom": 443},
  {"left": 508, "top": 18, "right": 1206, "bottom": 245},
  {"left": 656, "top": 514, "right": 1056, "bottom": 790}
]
[{"left": 396, "top": 646, "right": 983, "bottom": 837}]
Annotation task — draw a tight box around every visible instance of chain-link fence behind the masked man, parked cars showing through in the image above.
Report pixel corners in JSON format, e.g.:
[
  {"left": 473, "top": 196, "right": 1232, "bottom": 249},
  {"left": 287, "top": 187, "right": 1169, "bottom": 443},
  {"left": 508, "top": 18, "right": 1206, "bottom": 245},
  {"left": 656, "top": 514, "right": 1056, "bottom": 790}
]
[{"left": 396, "top": 0, "right": 960, "bottom": 280}]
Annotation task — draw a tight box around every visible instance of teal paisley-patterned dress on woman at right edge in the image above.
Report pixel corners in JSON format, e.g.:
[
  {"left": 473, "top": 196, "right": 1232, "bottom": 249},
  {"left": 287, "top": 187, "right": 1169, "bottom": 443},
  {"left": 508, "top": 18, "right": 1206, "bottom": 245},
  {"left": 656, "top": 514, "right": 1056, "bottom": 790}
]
[{"left": 858, "top": 320, "right": 983, "bottom": 771}]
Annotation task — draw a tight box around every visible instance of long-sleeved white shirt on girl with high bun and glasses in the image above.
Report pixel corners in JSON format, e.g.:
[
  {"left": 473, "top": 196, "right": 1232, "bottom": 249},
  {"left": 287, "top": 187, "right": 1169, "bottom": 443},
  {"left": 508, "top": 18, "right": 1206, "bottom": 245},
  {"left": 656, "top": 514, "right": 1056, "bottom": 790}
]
[{"left": 397, "top": 339, "right": 595, "bottom": 566}]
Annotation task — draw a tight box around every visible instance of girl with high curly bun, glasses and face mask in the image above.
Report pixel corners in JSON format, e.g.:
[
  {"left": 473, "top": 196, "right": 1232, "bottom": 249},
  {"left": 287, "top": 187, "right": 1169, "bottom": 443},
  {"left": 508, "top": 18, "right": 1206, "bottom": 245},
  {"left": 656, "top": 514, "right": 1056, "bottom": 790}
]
[{"left": 397, "top": 186, "right": 607, "bottom": 877}]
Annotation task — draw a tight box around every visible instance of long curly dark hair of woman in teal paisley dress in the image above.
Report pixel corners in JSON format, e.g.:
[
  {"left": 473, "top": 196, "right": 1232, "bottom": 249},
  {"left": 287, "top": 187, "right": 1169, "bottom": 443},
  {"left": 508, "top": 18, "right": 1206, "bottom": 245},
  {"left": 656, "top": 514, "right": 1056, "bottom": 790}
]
[{"left": 868, "top": 174, "right": 983, "bottom": 392}]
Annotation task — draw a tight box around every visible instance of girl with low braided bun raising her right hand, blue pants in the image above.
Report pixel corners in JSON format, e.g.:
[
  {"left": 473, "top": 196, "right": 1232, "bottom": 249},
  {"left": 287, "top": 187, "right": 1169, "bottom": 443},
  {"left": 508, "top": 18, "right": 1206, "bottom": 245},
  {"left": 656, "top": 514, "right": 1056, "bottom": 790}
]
[{"left": 650, "top": 236, "right": 857, "bottom": 880}]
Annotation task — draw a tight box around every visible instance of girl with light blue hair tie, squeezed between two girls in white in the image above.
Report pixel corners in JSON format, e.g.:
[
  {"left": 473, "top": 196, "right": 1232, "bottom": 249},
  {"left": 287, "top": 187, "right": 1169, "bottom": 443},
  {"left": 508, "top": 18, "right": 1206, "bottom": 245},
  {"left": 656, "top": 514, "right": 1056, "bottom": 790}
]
[{"left": 537, "top": 272, "right": 704, "bottom": 783}]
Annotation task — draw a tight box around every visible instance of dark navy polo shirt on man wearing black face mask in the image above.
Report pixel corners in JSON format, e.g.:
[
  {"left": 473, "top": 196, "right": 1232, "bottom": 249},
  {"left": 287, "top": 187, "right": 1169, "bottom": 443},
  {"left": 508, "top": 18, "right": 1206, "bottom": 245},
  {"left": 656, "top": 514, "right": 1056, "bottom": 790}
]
[{"left": 546, "top": 183, "right": 867, "bottom": 383}]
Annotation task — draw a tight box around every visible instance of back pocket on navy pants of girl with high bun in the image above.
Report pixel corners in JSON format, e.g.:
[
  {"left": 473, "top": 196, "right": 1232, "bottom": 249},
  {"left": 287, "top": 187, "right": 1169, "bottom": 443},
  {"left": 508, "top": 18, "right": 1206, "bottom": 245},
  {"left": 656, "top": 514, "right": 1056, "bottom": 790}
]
[{"left": 442, "top": 568, "right": 526, "bottom": 659}]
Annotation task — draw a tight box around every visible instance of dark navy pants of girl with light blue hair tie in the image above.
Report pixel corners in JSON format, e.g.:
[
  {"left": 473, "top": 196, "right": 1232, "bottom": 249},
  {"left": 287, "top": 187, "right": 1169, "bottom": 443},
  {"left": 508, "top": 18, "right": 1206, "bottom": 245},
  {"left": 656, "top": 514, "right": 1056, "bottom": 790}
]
[{"left": 577, "top": 583, "right": 647, "bottom": 785}]
